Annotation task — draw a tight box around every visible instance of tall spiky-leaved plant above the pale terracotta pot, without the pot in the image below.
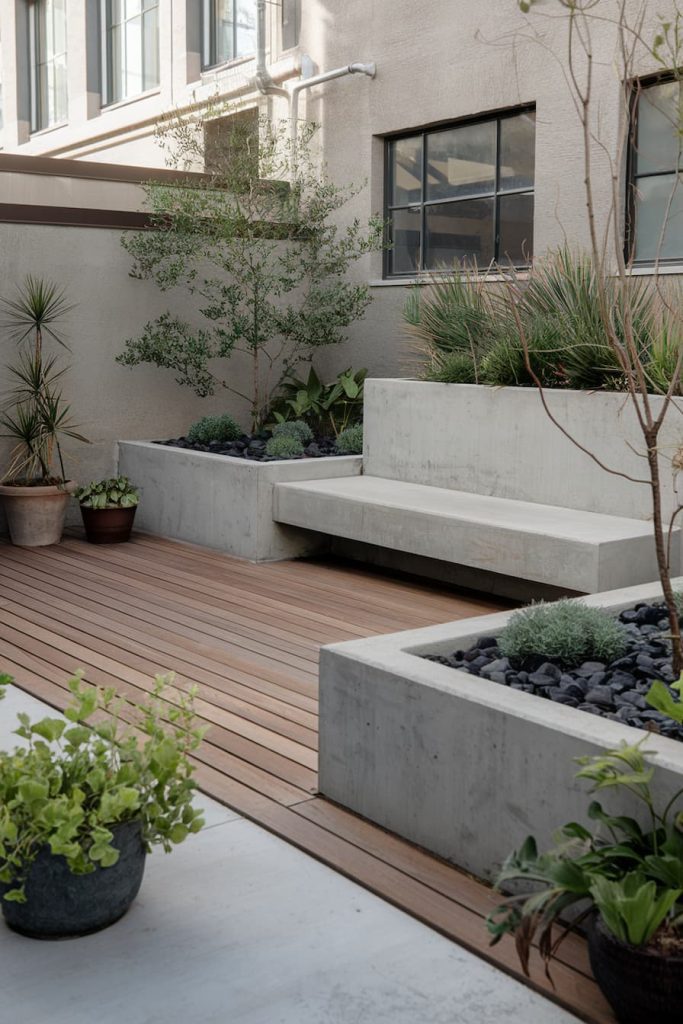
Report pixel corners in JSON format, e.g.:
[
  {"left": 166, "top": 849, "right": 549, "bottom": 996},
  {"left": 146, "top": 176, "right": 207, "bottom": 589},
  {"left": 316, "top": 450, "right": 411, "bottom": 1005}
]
[{"left": 0, "top": 275, "right": 87, "bottom": 485}]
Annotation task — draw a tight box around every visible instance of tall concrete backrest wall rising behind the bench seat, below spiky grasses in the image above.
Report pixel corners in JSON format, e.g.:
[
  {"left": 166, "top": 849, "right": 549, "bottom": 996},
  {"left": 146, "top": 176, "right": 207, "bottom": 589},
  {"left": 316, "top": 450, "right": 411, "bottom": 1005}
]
[{"left": 364, "top": 380, "right": 683, "bottom": 519}]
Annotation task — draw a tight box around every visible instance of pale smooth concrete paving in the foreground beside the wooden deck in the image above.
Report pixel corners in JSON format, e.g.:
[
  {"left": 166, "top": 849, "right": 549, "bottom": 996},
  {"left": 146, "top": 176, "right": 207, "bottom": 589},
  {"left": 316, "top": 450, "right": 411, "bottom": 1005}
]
[{"left": 0, "top": 679, "right": 575, "bottom": 1024}]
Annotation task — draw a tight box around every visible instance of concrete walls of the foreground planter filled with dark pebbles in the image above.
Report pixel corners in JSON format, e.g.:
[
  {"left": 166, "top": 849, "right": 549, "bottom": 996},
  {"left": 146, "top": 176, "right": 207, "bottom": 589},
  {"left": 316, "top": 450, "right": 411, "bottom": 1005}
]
[{"left": 319, "top": 581, "right": 683, "bottom": 878}]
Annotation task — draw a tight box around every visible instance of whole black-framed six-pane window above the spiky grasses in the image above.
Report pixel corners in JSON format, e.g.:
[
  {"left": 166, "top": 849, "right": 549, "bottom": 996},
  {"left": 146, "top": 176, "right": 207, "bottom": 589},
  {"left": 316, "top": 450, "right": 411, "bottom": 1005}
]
[{"left": 386, "top": 110, "right": 536, "bottom": 276}]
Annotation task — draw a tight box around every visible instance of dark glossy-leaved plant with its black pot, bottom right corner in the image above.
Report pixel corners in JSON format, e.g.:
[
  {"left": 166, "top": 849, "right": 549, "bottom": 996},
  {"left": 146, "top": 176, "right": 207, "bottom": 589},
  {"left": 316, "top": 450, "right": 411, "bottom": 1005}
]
[{"left": 487, "top": 744, "right": 683, "bottom": 1024}]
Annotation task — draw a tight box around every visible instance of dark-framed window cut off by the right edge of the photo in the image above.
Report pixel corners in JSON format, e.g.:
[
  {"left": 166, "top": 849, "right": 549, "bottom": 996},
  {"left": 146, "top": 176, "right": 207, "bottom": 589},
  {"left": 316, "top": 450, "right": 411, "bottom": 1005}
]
[{"left": 629, "top": 81, "right": 683, "bottom": 263}]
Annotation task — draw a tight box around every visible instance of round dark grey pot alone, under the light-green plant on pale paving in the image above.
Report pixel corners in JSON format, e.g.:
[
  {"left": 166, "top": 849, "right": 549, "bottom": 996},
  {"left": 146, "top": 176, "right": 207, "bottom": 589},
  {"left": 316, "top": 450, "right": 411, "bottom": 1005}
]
[{"left": 0, "top": 821, "right": 145, "bottom": 939}]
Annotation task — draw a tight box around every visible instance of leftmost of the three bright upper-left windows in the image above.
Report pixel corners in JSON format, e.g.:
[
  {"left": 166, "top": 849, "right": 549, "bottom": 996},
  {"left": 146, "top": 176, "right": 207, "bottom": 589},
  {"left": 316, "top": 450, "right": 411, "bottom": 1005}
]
[{"left": 29, "top": 0, "right": 67, "bottom": 131}]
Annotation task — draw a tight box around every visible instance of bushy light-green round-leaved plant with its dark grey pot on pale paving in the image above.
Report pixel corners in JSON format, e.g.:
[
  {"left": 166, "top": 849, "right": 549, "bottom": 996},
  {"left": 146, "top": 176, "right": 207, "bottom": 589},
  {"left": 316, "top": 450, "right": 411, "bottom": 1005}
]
[{"left": 0, "top": 673, "right": 204, "bottom": 938}]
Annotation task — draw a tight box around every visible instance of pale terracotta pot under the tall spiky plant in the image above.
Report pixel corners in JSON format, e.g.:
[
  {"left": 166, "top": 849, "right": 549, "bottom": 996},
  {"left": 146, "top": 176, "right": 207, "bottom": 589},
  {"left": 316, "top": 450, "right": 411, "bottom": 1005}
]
[{"left": 0, "top": 480, "right": 77, "bottom": 548}]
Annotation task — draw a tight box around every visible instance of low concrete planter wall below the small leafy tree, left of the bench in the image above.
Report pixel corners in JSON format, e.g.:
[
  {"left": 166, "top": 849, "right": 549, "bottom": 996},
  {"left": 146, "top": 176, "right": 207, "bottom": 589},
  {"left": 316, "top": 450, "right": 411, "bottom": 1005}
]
[{"left": 119, "top": 441, "right": 362, "bottom": 561}]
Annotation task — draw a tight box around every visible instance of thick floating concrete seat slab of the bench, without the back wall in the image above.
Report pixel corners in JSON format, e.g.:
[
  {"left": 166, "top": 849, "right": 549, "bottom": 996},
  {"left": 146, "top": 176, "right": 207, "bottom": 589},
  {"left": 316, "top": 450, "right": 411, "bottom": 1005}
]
[{"left": 273, "top": 475, "right": 680, "bottom": 593}]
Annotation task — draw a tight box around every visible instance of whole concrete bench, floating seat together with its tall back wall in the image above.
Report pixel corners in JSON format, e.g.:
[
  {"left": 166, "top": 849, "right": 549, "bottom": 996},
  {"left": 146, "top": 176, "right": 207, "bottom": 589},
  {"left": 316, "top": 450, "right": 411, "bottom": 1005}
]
[{"left": 272, "top": 380, "right": 681, "bottom": 594}]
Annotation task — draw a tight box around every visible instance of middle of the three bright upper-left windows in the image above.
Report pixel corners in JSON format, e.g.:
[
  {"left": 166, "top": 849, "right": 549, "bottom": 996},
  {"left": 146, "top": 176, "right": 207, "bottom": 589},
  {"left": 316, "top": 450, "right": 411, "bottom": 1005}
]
[{"left": 102, "top": 0, "right": 159, "bottom": 103}]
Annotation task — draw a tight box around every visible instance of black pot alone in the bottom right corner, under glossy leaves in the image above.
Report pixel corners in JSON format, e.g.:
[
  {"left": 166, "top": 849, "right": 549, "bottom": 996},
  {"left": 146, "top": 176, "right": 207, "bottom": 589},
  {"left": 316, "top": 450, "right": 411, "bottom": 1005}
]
[{"left": 589, "top": 916, "right": 683, "bottom": 1024}]
